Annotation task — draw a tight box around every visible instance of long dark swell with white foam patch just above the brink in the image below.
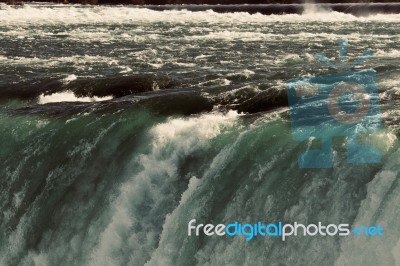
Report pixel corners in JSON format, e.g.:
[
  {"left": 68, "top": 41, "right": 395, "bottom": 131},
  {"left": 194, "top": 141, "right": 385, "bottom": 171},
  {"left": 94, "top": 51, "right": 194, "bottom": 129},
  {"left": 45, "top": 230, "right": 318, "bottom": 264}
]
[{"left": 7, "top": 82, "right": 287, "bottom": 116}]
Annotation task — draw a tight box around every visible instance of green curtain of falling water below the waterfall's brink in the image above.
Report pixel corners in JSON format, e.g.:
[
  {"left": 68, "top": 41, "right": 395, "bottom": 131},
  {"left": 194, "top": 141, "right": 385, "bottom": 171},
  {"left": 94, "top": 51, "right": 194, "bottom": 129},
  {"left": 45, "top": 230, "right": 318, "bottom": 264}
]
[{"left": 0, "top": 95, "right": 400, "bottom": 266}]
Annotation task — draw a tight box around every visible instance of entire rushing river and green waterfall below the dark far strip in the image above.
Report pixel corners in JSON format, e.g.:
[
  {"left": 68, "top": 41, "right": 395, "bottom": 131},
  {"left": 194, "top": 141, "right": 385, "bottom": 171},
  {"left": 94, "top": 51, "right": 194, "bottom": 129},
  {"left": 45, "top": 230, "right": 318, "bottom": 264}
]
[{"left": 0, "top": 4, "right": 400, "bottom": 266}]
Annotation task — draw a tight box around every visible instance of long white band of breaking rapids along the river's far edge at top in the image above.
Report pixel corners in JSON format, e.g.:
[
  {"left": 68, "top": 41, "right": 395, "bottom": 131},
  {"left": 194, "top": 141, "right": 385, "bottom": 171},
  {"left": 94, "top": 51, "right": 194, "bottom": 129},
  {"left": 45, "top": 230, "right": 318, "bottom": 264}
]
[{"left": 0, "top": 4, "right": 400, "bottom": 25}]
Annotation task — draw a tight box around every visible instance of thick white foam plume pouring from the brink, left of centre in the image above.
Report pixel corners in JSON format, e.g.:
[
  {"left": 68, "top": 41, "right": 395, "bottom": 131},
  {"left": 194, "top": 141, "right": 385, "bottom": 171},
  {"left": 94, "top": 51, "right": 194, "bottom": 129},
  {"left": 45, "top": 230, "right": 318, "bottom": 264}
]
[{"left": 91, "top": 112, "right": 238, "bottom": 266}]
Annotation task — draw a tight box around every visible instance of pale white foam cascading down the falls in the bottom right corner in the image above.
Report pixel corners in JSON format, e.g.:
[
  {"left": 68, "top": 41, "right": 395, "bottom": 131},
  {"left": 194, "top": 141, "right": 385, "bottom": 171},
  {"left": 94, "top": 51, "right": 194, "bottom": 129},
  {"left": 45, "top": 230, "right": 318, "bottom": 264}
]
[{"left": 335, "top": 150, "right": 400, "bottom": 266}]
